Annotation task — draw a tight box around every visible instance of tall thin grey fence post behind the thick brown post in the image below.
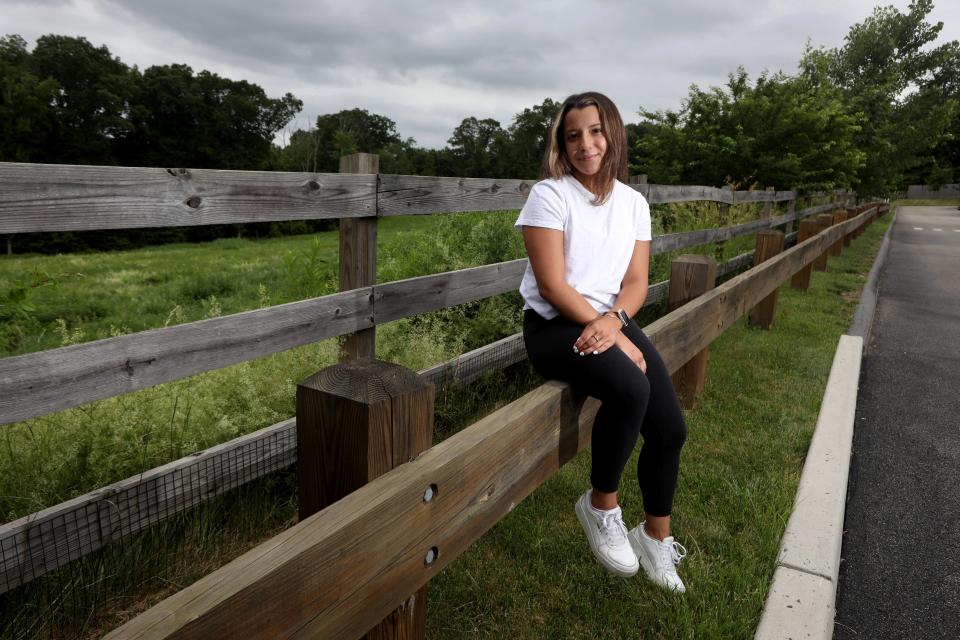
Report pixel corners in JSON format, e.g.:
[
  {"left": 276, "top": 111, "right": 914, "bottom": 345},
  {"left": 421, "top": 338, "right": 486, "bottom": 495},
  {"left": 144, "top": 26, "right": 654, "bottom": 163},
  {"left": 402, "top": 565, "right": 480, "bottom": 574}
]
[{"left": 340, "top": 153, "right": 380, "bottom": 362}]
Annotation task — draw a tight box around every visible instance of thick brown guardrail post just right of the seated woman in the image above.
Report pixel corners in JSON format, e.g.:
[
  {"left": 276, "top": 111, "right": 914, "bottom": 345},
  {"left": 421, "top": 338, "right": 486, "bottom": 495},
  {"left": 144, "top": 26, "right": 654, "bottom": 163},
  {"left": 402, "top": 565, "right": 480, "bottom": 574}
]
[{"left": 667, "top": 254, "right": 717, "bottom": 409}]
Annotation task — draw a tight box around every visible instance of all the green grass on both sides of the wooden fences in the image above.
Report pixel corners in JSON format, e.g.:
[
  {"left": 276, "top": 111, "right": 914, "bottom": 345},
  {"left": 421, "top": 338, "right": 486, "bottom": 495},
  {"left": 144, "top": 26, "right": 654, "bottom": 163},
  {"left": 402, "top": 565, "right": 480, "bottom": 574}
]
[{"left": 0, "top": 198, "right": 864, "bottom": 638}]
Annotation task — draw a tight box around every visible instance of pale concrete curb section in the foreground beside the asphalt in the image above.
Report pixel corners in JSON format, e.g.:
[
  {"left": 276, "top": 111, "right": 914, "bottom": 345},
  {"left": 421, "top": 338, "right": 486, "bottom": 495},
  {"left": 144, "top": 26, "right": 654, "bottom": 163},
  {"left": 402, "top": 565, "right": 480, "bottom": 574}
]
[{"left": 754, "top": 335, "right": 864, "bottom": 640}]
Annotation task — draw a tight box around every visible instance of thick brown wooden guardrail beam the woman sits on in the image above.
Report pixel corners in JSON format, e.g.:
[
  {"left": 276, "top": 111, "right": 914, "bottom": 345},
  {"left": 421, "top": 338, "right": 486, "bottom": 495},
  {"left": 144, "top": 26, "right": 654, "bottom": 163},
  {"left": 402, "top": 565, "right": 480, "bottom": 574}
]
[{"left": 107, "top": 208, "right": 877, "bottom": 640}]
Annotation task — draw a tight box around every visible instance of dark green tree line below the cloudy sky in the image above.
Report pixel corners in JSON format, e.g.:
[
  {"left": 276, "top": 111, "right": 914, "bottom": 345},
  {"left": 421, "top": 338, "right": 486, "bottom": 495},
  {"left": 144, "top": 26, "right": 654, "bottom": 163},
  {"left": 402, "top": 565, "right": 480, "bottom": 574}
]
[{"left": 0, "top": 0, "right": 960, "bottom": 255}]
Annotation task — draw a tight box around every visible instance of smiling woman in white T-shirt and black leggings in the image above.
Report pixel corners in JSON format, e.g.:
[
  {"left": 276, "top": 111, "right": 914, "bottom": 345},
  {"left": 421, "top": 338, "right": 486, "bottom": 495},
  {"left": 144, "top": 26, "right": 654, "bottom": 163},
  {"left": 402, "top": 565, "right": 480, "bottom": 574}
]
[{"left": 516, "top": 92, "right": 686, "bottom": 592}]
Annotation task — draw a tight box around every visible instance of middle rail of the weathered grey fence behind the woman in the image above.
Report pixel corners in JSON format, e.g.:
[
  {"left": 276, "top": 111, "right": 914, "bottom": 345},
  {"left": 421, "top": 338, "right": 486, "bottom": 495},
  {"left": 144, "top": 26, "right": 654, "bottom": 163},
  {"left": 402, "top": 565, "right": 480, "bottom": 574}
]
[{"left": 0, "top": 200, "right": 836, "bottom": 425}]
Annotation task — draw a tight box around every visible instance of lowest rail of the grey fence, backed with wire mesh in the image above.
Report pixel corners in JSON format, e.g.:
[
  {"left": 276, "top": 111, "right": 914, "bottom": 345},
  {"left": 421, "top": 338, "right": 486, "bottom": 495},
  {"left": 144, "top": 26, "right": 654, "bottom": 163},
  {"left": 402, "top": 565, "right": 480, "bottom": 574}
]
[{"left": 0, "top": 246, "right": 753, "bottom": 594}]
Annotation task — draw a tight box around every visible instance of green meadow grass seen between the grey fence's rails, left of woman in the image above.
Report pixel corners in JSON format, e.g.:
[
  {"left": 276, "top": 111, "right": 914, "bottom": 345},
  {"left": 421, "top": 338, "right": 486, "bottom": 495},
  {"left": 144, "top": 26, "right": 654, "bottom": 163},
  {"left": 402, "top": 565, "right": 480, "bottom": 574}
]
[{"left": 0, "top": 212, "right": 523, "bottom": 522}]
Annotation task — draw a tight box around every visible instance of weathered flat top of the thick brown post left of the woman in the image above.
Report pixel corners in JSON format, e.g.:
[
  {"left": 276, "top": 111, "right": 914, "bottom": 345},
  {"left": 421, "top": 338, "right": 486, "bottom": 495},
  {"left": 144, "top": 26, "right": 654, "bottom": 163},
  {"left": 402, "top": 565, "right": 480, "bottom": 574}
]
[{"left": 297, "top": 359, "right": 433, "bottom": 404}]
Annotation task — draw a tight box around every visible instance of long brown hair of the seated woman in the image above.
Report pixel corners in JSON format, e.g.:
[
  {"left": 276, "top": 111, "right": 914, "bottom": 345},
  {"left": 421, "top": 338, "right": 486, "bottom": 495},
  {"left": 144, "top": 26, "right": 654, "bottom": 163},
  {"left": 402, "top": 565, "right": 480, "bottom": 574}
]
[{"left": 540, "top": 91, "right": 627, "bottom": 205}]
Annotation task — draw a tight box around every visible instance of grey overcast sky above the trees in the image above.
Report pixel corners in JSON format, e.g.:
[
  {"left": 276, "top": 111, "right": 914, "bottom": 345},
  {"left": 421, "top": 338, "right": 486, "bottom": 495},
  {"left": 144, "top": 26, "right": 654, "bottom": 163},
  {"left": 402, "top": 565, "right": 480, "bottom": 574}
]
[{"left": 0, "top": 0, "right": 960, "bottom": 147}]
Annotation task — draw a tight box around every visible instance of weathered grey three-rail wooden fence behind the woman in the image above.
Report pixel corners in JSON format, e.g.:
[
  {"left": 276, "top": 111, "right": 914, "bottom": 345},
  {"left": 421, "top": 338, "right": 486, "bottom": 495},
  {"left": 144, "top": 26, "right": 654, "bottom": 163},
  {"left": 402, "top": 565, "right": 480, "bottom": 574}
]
[{"left": 0, "top": 154, "right": 876, "bottom": 632}]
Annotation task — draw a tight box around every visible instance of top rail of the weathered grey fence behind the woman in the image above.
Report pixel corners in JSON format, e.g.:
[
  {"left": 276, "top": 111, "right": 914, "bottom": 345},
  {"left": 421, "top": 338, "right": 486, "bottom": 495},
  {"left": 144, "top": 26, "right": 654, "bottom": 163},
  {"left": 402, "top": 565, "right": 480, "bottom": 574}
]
[{"left": 0, "top": 162, "right": 845, "bottom": 234}]
